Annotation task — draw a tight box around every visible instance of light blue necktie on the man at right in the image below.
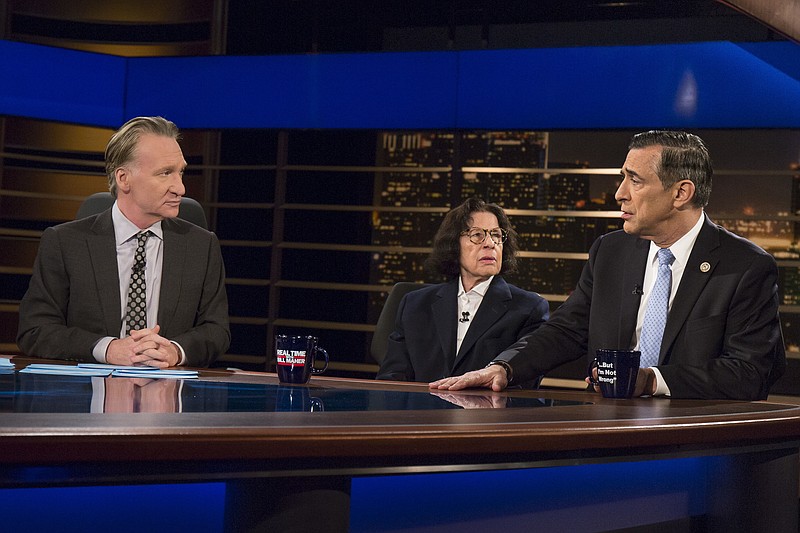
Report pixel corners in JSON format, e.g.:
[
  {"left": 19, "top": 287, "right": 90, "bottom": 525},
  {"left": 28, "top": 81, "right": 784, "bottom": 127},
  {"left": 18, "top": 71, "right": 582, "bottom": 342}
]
[{"left": 639, "top": 248, "right": 675, "bottom": 368}]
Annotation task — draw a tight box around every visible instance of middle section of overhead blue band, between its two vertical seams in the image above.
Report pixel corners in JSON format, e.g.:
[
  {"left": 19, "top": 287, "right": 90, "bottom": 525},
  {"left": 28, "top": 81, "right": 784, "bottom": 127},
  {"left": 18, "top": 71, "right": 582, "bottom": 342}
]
[{"left": 126, "top": 52, "right": 457, "bottom": 129}]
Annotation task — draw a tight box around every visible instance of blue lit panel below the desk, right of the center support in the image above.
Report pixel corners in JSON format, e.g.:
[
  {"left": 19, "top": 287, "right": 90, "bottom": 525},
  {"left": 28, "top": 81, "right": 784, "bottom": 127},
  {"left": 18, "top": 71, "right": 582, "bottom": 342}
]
[{"left": 350, "top": 458, "right": 711, "bottom": 533}]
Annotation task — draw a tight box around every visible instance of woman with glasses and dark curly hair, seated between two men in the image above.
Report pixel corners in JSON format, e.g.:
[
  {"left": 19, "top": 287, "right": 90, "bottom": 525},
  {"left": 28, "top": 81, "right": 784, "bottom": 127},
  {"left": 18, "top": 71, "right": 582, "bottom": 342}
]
[{"left": 377, "top": 198, "right": 549, "bottom": 382}]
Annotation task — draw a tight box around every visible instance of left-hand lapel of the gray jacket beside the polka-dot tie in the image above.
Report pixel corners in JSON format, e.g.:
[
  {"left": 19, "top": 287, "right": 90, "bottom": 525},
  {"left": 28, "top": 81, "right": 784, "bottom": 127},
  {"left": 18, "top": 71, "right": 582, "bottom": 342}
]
[{"left": 86, "top": 209, "right": 122, "bottom": 337}]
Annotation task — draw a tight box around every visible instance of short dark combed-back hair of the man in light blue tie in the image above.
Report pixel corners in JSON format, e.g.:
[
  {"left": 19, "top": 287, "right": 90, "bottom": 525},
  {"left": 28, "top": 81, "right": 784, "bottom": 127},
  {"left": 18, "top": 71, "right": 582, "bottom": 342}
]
[{"left": 628, "top": 130, "right": 714, "bottom": 207}]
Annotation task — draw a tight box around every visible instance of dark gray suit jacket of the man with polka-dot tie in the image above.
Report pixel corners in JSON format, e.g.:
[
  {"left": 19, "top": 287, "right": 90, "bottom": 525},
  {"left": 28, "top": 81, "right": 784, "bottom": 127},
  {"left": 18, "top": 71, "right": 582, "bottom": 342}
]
[{"left": 17, "top": 209, "right": 230, "bottom": 366}]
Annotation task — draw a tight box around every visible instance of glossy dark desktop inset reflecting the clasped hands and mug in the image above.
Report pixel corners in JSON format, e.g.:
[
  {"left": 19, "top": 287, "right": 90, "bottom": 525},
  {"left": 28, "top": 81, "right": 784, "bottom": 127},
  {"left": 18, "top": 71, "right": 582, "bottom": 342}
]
[{"left": 0, "top": 372, "right": 585, "bottom": 413}]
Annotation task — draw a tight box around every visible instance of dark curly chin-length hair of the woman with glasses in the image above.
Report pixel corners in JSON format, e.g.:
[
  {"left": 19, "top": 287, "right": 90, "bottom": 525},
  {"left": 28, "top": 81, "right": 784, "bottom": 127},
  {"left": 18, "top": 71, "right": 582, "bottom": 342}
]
[{"left": 425, "top": 198, "right": 519, "bottom": 279}]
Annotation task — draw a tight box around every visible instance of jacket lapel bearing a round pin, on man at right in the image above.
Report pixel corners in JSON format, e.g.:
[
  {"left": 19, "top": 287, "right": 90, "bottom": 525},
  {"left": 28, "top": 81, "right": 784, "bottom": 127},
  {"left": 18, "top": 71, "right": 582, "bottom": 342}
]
[{"left": 659, "top": 214, "right": 719, "bottom": 362}]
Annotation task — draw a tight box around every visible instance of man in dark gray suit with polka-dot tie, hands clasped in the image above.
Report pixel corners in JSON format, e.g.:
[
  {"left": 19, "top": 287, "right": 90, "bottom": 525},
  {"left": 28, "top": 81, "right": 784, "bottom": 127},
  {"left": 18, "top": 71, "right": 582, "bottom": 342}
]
[{"left": 17, "top": 117, "right": 230, "bottom": 367}]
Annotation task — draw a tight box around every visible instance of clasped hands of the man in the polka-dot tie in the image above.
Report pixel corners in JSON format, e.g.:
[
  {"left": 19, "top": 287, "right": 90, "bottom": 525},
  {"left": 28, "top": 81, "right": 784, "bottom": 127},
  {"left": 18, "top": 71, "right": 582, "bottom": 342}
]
[{"left": 106, "top": 326, "right": 180, "bottom": 368}]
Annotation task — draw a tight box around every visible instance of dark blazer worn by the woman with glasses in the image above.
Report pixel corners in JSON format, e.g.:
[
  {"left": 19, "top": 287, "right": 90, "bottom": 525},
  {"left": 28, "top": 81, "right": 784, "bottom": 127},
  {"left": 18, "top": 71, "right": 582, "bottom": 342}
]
[{"left": 377, "top": 276, "right": 549, "bottom": 382}]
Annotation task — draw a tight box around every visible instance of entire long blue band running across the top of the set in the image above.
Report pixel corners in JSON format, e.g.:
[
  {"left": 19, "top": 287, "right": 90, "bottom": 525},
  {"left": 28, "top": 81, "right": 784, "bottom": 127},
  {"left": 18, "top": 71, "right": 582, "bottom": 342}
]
[{"left": 0, "top": 41, "right": 800, "bottom": 130}]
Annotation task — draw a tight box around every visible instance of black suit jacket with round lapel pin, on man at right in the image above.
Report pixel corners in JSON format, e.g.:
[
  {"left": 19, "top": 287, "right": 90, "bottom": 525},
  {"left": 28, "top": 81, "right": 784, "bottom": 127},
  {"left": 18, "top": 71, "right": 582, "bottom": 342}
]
[{"left": 498, "top": 215, "right": 786, "bottom": 400}]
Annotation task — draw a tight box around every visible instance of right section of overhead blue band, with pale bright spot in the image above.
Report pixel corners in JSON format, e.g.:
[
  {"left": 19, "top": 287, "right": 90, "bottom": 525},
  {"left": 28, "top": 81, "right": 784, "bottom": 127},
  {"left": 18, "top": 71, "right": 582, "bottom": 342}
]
[{"left": 458, "top": 42, "right": 800, "bottom": 130}]
